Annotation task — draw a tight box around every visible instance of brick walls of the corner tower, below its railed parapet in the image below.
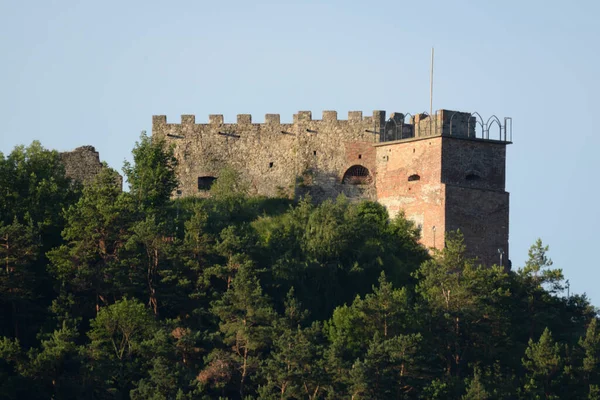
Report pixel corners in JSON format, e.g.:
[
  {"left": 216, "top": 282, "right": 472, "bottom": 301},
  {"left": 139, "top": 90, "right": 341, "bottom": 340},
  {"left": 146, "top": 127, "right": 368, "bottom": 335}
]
[{"left": 375, "top": 136, "right": 509, "bottom": 264}]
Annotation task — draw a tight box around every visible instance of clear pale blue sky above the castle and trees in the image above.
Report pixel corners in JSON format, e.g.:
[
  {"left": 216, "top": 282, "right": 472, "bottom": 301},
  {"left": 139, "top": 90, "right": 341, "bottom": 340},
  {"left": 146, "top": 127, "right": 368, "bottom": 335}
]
[{"left": 0, "top": 0, "right": 600, "bottom": 305}]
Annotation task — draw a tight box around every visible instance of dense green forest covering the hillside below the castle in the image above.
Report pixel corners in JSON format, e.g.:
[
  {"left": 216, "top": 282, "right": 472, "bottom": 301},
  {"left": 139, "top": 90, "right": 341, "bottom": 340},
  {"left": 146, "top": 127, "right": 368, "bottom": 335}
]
[{"left": 0, "top": 135, "right": 600, "bottom": 400}]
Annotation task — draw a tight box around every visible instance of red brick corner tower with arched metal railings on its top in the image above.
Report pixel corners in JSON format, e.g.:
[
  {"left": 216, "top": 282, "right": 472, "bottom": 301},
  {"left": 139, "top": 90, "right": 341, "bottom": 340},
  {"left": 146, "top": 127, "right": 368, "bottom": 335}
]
[{"left": 375, "top": 110, "right": 511, "bottom": 268}]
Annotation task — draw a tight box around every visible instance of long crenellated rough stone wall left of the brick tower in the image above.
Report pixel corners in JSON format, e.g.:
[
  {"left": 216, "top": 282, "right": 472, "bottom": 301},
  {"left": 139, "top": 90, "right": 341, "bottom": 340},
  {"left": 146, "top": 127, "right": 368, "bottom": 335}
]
[{"left": 152, "top": 111, "right": 385, "bottom": 200}]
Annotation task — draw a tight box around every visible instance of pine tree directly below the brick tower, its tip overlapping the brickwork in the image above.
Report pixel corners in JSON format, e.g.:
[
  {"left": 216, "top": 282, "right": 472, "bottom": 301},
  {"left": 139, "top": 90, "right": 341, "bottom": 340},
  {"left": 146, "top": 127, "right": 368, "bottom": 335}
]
[{"left": 415, "top": 233, "right": 511, "bottom": 376}]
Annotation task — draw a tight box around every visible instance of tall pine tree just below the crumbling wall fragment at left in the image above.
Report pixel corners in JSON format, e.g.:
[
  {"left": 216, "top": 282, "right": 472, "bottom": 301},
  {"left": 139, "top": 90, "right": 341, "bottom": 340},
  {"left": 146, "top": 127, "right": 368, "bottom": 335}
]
[{"left": 47, "top": 168, "right": 133, "bottom": 318}]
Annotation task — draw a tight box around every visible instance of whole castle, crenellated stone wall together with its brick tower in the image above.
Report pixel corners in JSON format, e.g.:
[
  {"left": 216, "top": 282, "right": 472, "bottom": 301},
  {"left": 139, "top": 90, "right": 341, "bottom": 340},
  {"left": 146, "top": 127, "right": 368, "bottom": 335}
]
[{"left": 152, "top": 110, "right": 510, "bottom": 264}]
